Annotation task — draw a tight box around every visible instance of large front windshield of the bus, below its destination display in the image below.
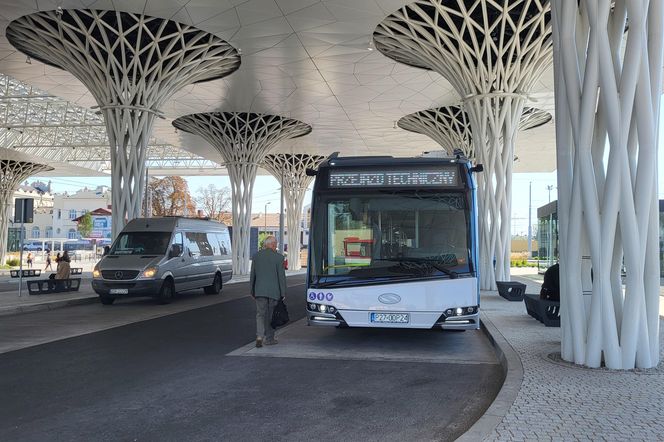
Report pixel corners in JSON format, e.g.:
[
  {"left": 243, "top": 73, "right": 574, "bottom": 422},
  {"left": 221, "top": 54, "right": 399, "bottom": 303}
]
[{"left": 310, "top": 191, "right": 473, "bottom": 286}]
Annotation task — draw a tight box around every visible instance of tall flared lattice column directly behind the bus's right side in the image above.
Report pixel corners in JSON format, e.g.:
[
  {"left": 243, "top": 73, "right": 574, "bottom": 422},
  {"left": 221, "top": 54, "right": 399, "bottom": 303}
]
[{"left": 373, "top": 0, "right": 552, "bottom": 290}]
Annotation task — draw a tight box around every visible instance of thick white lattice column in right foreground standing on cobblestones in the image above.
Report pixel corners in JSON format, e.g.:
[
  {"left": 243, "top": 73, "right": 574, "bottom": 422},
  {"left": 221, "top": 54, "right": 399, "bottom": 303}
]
[{"left": 552, "top": 0, "right": 664, "bottom": 369}]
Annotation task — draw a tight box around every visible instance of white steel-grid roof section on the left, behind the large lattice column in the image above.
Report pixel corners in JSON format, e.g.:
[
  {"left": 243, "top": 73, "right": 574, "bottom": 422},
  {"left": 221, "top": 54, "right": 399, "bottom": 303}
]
[{"left": 0, "top": 73, "right": 224, "bottom": 176}]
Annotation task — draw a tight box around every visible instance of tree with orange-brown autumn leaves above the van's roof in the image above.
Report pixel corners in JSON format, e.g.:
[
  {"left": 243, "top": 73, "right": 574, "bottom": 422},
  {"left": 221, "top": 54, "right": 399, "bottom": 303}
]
[{"left": 148, "top": 176, "right": 196, "bottom": 216}]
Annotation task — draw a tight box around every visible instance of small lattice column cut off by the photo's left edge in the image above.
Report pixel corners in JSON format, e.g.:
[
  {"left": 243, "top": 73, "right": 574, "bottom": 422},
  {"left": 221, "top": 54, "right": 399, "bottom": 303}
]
[{"left": 0, "top": 159, "right": 53, "bottom": 264}]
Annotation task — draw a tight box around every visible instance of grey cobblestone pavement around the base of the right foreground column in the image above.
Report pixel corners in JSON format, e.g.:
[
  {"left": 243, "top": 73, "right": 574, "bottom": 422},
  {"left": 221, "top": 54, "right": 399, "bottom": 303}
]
[{"left": 481, "top": 277, "right": 664, "bottom": 441}]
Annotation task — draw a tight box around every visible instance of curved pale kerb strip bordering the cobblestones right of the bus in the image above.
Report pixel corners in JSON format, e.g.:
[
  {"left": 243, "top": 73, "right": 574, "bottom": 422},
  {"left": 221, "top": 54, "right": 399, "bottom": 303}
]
[{"left": 457, "top": 313, "right": 523, "bottom": 442}]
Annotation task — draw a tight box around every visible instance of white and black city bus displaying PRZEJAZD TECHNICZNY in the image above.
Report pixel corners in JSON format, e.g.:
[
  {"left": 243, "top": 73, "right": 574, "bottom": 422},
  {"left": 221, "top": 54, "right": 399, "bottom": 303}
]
[{"left": 306, "top": 155, "right": 482, "bottom": 330}]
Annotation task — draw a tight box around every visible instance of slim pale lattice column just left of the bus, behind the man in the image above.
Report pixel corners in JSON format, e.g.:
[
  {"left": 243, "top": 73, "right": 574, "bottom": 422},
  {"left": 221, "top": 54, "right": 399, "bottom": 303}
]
[{"left": 263, "top": 153, "right": 325, "bottom": 270}]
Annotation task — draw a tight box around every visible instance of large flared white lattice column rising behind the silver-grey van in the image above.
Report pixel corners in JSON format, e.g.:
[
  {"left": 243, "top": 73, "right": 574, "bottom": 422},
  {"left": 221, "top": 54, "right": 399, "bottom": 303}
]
[{"left": 6, "top": 9, "right": 240, "bottom": 236}]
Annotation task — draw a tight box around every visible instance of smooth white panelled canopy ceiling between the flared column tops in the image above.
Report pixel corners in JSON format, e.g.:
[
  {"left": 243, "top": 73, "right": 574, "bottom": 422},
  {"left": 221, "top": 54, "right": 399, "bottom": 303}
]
[{"left": 0, "top": 0, "right": 555, "bottom": 172}]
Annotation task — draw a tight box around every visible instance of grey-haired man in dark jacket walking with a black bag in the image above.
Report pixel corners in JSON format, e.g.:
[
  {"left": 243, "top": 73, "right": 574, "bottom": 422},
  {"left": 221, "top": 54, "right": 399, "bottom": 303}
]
[{"left": 250, "top": 236, "right": 286, "bottom": 347}]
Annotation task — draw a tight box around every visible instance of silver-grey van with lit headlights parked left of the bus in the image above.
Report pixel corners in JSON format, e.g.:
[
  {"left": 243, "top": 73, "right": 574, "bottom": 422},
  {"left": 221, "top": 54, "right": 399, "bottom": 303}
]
[{"left": 92, "top": 217, "right": 233, "bottom": 305}]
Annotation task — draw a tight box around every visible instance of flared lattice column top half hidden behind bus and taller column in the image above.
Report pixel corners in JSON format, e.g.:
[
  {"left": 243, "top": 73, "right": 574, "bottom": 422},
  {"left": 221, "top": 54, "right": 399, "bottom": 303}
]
[{"left": 397, "top": 106, "right": 553, "bottom": 161}]
